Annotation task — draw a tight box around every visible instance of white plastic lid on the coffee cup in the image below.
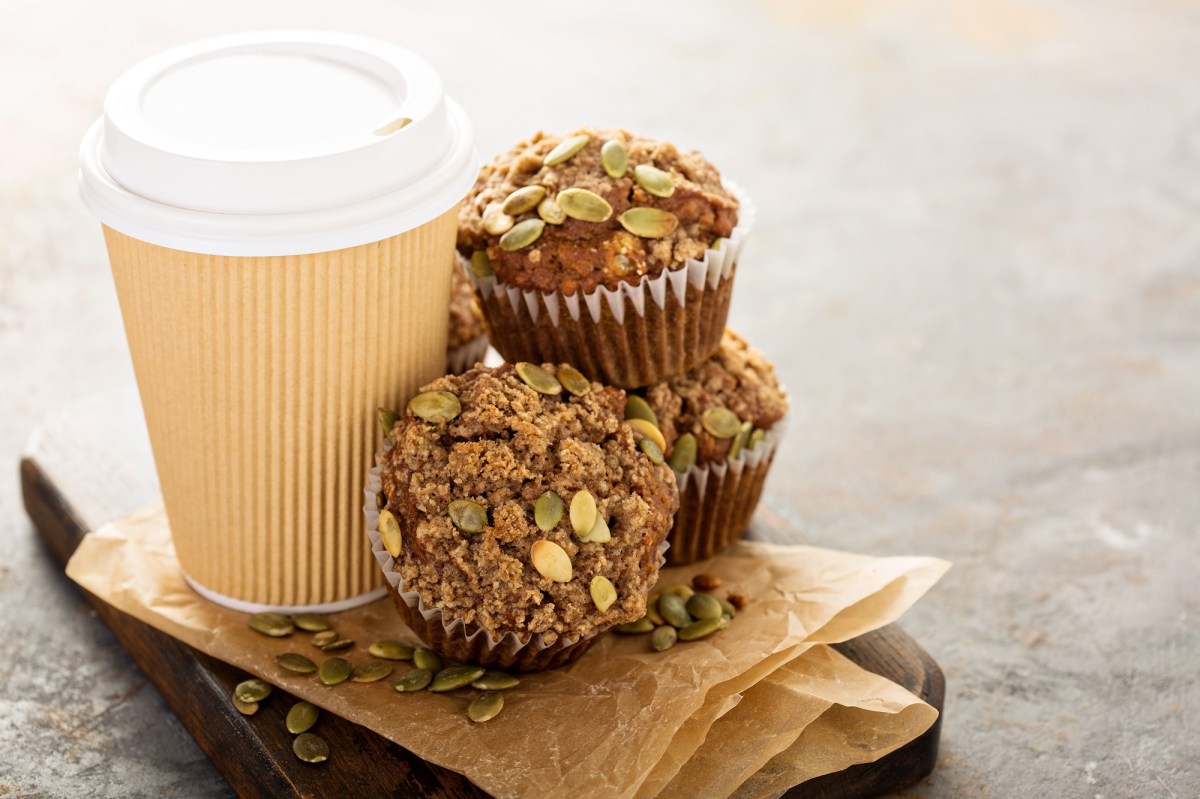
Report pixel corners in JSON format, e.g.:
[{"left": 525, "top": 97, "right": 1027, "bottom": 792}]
[{"left": 79, "top": 31, "right": 479, "bottom": 256}]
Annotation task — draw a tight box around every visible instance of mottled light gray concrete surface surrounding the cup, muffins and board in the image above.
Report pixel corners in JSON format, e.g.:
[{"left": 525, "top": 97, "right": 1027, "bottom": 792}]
[{"left": 0, "top": 0, "right": 1200, "bottom": 799}]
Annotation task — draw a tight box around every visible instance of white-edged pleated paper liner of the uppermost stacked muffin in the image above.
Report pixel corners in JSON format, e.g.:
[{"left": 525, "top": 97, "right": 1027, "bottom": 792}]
[{"left": 466, "top": 182, "right": 756, "bottom": 389}]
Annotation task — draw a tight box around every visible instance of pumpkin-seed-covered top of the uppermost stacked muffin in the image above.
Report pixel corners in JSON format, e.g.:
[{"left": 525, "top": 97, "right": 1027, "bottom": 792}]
[{"left": 458, "top": 128, "right": 738, "bottom": 295}]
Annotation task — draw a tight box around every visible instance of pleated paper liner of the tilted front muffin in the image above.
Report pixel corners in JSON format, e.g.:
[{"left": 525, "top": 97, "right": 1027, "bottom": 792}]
[{"left": 362, "top": 440, "right": 670, "bottom": 672}]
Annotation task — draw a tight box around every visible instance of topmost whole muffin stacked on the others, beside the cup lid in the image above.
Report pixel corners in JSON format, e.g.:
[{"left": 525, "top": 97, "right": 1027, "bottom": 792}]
[{"left": 458, "top": 128, "right": 752, "bottom": 388}]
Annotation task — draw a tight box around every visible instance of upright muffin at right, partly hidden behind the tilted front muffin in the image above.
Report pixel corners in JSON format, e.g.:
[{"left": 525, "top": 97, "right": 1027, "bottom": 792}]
[{"left": 626, "top": 330, "right": 787, "bottom": 565}]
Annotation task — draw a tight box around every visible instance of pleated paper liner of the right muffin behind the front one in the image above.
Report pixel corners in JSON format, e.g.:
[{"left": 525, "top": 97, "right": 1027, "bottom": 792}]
[{"left": 667, "top": 420, "right": 785, "bottom": 566}]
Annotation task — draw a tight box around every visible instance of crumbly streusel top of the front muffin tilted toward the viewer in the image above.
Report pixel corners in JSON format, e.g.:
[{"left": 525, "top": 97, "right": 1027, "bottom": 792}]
[{"left": 382, "top": 364, "right": 678, "bottom": 643}]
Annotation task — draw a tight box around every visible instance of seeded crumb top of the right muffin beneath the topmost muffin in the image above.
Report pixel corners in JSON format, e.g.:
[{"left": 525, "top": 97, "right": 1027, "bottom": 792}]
[{"left": 630, "top": 329, "right": 787, "bottom": 471}]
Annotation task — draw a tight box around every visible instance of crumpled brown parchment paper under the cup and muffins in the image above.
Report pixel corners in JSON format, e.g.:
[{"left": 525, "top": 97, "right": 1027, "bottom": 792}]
[{"left": 67, "top": 505, "right": 949, "bottom": 798}]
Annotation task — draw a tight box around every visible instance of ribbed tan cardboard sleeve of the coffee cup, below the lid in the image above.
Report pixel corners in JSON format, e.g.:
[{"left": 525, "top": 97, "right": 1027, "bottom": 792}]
[{"left": 104, "top": 209, "right": 457, "bottom": 606}]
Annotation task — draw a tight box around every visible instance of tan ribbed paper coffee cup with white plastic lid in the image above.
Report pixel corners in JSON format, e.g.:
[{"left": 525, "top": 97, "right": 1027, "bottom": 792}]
[{"left": 79, "top": 31, "right": 479, "bottom": 611}]
